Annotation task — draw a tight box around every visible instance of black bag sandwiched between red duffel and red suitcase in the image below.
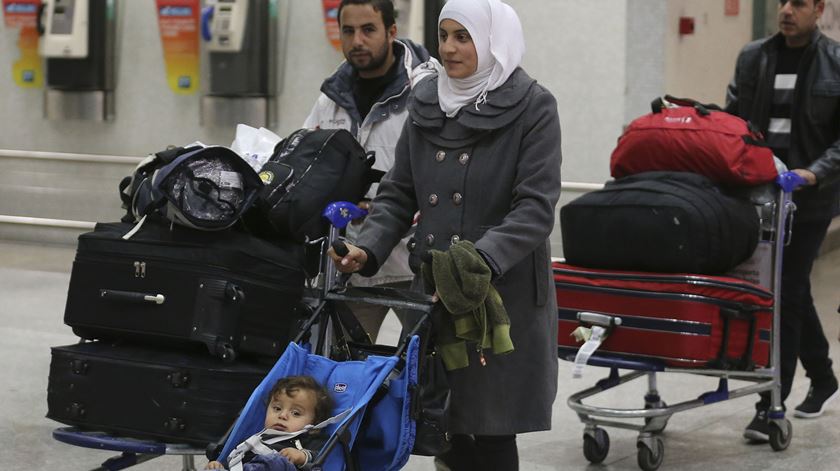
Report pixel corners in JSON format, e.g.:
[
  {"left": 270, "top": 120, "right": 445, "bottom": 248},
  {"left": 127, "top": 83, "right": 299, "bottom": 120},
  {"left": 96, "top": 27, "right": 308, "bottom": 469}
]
[{"left": 560, "top": 172, "right": 759, "bottom": 275}]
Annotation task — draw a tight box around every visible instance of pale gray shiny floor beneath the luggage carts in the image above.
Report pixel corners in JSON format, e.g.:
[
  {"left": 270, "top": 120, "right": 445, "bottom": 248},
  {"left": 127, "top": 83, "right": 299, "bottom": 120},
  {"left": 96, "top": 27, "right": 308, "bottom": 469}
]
[{"left": 0, "top": 243, "right": 840, "bottom": 471}]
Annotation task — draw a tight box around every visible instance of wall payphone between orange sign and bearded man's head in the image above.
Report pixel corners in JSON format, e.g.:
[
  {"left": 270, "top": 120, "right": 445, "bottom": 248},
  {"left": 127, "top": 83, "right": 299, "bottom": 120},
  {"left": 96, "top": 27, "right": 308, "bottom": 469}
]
[{"left": 201, "top": 0, "right": 277, "bottom": 127}]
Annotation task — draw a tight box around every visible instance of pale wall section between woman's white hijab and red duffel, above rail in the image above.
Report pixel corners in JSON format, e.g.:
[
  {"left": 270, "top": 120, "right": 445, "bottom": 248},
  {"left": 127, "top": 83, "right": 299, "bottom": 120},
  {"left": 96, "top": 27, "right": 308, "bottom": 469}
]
[{"left": 509, "top": 0, "right": 627, "bottom": 183}]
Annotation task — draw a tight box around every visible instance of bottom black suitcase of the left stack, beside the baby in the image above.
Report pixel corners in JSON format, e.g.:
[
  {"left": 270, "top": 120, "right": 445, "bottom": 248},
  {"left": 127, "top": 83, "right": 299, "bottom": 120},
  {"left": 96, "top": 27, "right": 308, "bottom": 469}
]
[{"left": 47, "top": 342, "right": 271, "bottom": 446}]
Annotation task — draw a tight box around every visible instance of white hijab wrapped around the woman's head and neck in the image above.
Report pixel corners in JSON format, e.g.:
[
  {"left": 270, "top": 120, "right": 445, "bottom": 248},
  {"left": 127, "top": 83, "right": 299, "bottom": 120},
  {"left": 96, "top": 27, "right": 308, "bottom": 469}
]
[{"left": 437, "top": 0, "right": 525, "bottom": 118}]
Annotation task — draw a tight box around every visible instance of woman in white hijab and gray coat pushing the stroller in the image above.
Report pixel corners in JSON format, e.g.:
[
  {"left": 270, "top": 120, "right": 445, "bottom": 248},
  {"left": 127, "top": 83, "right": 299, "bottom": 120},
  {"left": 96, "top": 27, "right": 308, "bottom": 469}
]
[{"left": 332, "top": 0, "right": 561, "bottom": 471}]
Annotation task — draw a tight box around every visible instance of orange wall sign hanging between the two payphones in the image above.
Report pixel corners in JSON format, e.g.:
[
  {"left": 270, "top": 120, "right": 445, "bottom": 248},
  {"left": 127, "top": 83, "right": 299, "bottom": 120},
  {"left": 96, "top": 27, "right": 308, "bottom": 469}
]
[{"left": 156, "top": 0, "right": 199, "bottom": 95}]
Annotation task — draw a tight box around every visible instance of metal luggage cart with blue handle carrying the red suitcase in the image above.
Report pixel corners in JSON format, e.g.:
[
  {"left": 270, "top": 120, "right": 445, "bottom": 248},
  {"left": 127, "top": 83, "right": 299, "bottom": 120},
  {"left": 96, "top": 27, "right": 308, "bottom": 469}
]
[{"left": 558, "top": 185, "right": 795, "bottom": 471}]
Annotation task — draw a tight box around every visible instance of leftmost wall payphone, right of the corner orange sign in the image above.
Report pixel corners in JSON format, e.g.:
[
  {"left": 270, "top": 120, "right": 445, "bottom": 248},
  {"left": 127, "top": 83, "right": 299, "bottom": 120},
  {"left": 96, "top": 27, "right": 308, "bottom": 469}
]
[{"left": 38, "top": 0, "right": 116, "bottom": 121}]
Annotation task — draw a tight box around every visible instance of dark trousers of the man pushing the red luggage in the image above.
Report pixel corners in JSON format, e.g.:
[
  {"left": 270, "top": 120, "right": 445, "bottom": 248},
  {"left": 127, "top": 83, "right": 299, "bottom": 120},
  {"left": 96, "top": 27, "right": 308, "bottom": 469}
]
[{"left": 756, "top": 218, "right": 834, "bottom": 409}]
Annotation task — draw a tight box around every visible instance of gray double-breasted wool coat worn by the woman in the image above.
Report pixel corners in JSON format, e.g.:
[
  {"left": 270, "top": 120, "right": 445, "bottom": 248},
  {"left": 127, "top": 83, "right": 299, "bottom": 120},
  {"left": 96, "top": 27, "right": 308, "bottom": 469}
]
[{"left": 358, "top": 69, "right": 561, "bottom": 435}]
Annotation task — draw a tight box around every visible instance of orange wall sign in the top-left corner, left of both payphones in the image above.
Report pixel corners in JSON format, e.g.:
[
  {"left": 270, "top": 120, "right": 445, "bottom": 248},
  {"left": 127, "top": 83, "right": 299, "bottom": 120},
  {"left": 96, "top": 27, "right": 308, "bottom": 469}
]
[{"left": 3, "top": 0, "right": 44, "bottom": 88}]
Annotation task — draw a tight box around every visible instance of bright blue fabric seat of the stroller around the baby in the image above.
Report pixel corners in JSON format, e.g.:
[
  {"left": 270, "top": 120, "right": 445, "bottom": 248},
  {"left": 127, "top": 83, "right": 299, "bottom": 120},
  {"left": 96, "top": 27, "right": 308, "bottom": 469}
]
[{"left": 213, "top": 314, "right": 420, "bottom": 470}]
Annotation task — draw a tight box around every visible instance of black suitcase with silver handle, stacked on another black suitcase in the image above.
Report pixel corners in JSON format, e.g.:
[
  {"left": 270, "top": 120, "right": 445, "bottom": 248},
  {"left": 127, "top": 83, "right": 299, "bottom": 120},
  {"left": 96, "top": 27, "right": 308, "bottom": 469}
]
[{"left": 64, "top": 218, "right": 304, "bottom": 360}]
